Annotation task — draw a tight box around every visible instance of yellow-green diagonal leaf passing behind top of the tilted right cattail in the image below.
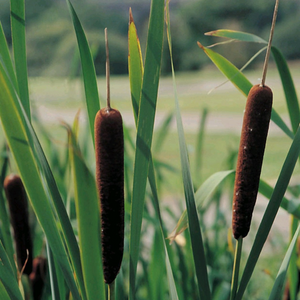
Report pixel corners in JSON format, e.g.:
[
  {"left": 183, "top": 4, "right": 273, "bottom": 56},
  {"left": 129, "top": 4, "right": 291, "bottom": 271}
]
[{"left": 198, "top": 42, "right": 294, "bottom": 138}]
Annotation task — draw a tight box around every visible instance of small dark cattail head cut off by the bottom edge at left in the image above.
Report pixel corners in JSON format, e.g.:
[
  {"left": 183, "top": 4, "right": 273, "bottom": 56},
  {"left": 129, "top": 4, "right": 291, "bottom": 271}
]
[{"left": 29, "top": 256, "right": 47, "bottom": 300}]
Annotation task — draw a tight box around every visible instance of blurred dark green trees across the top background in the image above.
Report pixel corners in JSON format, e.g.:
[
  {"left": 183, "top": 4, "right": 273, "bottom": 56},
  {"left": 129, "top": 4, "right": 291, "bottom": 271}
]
[{"left": 0, "top": 0, "right": 300, "bottom": 76}]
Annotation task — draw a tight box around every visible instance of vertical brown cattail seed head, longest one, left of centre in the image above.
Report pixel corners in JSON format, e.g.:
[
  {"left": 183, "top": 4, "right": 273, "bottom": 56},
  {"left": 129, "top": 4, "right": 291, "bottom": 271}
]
[{"left": 95, "top": 108, "right": 124, "bottom": 284}]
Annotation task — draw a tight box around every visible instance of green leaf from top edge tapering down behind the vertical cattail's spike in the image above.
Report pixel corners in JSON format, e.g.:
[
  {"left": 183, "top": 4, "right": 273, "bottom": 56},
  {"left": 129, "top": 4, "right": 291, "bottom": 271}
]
[{"left": 67, "top": 0, "right": 100, "bottom": 145}]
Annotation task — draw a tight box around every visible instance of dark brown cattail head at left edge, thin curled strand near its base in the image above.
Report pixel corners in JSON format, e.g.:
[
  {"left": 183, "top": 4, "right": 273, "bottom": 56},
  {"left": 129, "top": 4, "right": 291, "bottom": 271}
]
[{"left": 3, "top": 174, "right": 32, "bottom": 275}]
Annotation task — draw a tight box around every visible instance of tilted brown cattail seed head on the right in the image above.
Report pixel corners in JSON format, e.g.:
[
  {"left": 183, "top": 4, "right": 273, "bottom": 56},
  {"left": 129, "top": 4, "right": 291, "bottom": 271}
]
[{"left": 232, "top": 85, "right": 273, "bottom": 239}]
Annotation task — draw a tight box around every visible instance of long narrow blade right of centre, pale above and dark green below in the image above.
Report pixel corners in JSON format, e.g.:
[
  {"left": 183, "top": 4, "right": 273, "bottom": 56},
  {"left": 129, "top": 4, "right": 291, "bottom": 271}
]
[{"left": 166, "top": 1, "right": 211, "bottom": 300}]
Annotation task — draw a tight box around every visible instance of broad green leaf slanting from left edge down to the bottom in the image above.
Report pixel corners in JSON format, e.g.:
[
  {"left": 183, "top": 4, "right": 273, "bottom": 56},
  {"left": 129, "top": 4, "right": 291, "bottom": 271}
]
[{"left": 0, "top": 64, "right": 80, "bottom": 299}]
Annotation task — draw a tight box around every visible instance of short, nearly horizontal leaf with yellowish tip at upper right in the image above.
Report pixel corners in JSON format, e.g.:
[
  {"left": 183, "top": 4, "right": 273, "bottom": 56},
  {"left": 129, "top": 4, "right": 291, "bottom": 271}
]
[{"left": 205, "top": 29, "right": 268, "bottom": 44}]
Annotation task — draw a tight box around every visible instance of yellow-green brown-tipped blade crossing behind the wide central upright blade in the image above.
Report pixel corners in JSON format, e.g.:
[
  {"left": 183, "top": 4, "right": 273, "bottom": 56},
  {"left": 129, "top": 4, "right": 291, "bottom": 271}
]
[{"left": 128, "top": 10, "right": 178, "bottom": 300}]
